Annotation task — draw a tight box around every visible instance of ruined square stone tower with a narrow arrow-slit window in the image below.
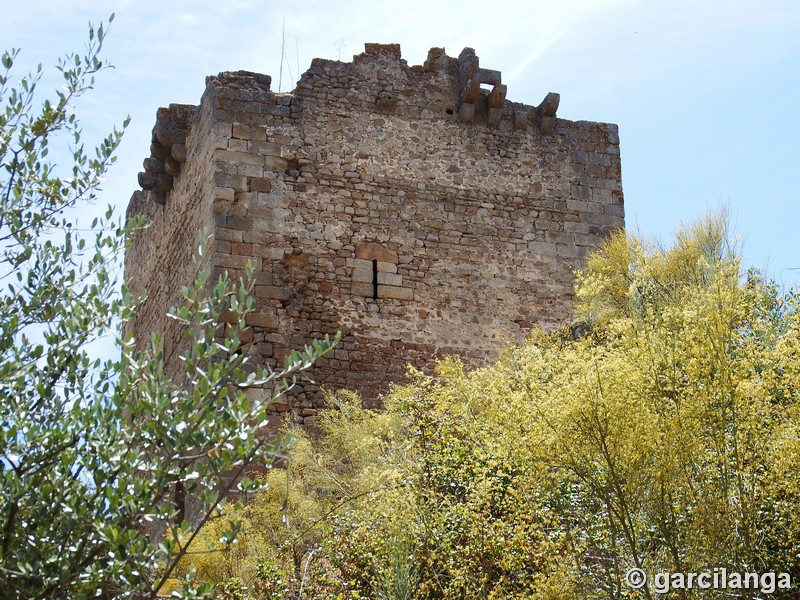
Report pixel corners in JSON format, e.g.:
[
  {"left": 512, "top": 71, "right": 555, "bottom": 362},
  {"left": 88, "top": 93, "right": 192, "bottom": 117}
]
[{"left": 125, "top": 44, "right": 624, "bottom": 424}]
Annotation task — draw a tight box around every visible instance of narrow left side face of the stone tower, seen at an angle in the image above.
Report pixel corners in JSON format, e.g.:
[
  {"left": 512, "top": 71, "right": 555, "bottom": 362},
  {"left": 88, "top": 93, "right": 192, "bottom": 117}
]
[{"left": 125, "top": 104, "right": 219, "bottom": 375}]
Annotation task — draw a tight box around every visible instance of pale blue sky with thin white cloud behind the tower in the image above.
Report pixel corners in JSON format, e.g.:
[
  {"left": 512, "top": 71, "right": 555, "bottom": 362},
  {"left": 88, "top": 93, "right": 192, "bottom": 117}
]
[{"left": 6, "top": 0, "right": 800, "bottom": 286}]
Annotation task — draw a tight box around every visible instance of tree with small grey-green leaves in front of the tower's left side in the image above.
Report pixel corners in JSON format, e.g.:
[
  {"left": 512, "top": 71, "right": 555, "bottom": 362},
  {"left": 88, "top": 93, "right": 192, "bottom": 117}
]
[{"left": 0, "top": 15, "right": 331, "bottom": 599}]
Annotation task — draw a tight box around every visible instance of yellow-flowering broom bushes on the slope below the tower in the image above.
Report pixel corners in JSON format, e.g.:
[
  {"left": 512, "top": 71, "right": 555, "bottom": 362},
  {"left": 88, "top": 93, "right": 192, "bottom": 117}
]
[{"left": 180, "top": 217, "right": 800, "bottom": 600}]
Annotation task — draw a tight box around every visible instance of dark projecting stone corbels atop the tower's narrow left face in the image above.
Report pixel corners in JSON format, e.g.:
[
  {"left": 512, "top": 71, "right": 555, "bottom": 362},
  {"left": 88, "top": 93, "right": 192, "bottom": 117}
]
[{"left": 139, "top": 104, "right": 196, "bottom": 204}]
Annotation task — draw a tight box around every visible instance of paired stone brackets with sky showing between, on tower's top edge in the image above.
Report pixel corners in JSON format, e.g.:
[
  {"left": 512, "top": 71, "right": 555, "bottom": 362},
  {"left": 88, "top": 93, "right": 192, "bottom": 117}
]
[{"left": 458, "top": 48, "right": 507, "bottom": 127}]
